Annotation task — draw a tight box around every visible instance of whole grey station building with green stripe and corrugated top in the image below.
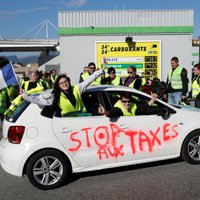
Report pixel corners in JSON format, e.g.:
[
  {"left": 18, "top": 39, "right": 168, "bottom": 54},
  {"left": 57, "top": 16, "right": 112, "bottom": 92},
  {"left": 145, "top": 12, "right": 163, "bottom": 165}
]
[{"left": 58, "top": 9, "right": 194, "bottom": 83}]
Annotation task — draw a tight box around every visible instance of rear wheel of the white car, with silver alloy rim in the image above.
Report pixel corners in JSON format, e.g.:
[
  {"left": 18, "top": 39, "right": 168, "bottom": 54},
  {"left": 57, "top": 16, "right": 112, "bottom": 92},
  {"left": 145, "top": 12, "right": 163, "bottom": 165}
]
[{"left": 26, "top": 149, "right": 71, "bottom": 190}]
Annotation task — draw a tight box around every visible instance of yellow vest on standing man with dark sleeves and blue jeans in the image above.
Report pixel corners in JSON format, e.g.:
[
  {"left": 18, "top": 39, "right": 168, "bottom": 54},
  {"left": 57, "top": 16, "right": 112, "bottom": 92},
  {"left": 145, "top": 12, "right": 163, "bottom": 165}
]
[{"left": 168, "top": 66, "right": 183, "bottom": 89}]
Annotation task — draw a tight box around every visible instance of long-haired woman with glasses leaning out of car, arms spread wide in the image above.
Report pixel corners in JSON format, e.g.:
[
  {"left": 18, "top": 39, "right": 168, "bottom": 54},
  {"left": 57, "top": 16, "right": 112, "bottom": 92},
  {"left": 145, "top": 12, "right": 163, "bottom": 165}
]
[{"left": 23, "top": 63, "right": 107, "bottom": 117}]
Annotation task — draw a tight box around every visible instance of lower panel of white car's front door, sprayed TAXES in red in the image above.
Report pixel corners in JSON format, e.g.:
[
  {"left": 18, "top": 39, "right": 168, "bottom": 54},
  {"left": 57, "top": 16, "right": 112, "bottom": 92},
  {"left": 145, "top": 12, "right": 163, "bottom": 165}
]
[{"left": 105, "top": 90, "right": 179, "bottom": 163}]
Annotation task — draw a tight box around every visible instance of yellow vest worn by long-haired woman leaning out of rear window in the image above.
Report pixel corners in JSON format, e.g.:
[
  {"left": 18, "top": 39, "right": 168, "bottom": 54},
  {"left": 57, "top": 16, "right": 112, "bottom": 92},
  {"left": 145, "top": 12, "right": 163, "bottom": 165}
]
[{"left": 58, "top": 85, "right": 83, "bottom": 117}]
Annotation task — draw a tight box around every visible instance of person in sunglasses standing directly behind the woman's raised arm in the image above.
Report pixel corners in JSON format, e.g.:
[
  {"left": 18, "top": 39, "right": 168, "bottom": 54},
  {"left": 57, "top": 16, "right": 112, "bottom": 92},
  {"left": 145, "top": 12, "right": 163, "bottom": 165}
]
[{"left": 79, "top": 62, "right": 101, "bottom": 86}]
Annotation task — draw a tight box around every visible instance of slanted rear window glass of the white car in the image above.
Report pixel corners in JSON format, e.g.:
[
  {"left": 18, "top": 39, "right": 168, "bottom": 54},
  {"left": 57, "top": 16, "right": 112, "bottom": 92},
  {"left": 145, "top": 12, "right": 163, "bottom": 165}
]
[{"left": 5, "top": 101, "right": 30, "bottom": 122}]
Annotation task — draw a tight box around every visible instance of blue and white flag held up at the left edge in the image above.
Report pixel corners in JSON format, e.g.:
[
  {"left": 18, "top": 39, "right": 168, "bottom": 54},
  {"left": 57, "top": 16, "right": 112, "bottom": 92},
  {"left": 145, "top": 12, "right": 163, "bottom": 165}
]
[{"left": 0, "top": 57, "right": 18, "bottom": 89}]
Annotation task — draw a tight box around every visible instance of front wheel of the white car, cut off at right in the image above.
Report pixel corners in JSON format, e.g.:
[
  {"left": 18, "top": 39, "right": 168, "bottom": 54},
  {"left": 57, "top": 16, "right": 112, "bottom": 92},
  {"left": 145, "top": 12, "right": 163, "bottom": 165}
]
[{"left": 181, "top": 130, "right": 200, "bottom": 164}]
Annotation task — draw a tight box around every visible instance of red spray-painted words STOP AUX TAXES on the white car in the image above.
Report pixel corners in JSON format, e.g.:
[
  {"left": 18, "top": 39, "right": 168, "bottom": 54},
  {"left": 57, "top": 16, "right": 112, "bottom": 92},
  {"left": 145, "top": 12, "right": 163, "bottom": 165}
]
[{"left": 68, "top": 123, "right": 179, "bottom": 160}]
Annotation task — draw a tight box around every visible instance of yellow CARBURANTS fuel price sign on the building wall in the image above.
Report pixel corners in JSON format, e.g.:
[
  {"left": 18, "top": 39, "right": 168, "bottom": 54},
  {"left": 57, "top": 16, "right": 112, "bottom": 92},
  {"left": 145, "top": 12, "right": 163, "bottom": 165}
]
[{"left": 96, "top": 41, "right": 161, "bottom": 78}]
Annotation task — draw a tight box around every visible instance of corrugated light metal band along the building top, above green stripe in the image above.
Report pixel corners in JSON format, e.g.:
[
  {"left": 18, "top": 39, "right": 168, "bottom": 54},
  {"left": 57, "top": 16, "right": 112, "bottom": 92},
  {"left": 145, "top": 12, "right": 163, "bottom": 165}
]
[{"left": 58, "top": 9, "right": 194, "bottom": 28}]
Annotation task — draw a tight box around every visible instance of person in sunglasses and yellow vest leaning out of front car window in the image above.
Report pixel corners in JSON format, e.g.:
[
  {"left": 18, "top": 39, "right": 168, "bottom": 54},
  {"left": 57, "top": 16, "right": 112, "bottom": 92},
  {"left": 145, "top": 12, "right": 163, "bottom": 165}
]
[{"left": 98, "top": 92, "right": 158, "bottom": 118}]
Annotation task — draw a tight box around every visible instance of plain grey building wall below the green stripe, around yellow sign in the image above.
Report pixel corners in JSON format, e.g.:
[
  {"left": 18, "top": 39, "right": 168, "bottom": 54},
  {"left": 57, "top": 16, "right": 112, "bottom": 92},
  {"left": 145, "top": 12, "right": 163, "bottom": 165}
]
[{"left": 60, "top": 34, "right": 192, "bottom": 83}]
